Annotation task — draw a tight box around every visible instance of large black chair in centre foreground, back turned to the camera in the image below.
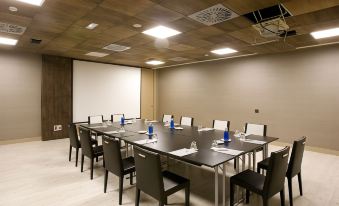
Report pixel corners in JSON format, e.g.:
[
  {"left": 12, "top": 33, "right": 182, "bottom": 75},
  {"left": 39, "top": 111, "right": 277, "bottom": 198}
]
[{"left": 134, "top": 147, "right": 190, "bottom": 206}]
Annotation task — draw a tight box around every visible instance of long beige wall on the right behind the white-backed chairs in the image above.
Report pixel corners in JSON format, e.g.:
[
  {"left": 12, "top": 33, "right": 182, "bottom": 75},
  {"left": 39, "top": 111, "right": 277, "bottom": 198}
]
[{"left": 157, "top": 46, "right": 339, "bottom": 150}]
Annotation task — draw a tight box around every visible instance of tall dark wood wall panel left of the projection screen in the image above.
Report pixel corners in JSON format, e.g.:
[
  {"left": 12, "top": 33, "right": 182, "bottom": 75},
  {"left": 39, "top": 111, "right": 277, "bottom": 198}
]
[{"left": 41, "top": 55, "right": 73, "bottom": 140}]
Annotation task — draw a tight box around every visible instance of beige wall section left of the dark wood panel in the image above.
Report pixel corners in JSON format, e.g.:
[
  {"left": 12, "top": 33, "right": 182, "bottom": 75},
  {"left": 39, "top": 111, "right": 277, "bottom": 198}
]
[{"left": 0, "top": 51, "right": 42, "bottom": 141}]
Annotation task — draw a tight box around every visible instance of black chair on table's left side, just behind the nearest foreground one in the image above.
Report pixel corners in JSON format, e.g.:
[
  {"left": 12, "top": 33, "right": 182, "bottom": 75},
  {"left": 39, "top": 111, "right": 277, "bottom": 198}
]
[{"left": 102, "top": 136, "right": 135, "bottom": 205}]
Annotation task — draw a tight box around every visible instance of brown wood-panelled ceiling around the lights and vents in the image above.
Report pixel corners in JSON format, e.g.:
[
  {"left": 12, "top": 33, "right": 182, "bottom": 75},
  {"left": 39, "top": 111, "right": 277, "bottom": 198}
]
[{"left": 0, "top": 0, "right": 339, "bottom": 67}]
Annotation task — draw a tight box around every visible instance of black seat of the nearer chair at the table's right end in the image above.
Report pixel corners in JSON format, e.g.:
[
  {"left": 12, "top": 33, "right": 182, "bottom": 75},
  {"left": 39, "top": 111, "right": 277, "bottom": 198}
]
[{"left": 231, "top": 170, "right": 265, "bottom": 194}]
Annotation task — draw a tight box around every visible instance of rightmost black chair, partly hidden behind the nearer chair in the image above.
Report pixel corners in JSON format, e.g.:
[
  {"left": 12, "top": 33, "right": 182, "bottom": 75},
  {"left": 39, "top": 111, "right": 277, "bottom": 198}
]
[{"left": 257, "top": 137, "right": 306, "bottom": 206}]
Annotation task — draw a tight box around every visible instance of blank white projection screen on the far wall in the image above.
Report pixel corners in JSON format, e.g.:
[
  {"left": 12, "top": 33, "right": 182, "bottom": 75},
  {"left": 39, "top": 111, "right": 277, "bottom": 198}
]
[{"left": 73, "top": 60, "right": 141, "bottom": 122}]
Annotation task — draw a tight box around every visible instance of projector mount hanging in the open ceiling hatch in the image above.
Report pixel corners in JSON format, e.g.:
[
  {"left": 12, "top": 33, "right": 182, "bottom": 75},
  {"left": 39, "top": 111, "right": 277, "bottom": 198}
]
[{"left": 245, "top": 4, "right": 291, "bottom": 38}]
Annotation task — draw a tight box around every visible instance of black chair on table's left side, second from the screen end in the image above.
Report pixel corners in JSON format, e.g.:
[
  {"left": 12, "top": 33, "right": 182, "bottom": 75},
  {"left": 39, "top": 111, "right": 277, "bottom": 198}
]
[{"left": 79, "top": 127, "right": 104, "bottom": 180}]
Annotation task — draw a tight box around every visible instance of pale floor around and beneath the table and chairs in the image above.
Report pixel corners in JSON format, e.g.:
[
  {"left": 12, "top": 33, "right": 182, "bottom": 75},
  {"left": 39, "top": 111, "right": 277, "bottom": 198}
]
[{"left": 0, "top": 139, "right": 339, "bottom": 206}]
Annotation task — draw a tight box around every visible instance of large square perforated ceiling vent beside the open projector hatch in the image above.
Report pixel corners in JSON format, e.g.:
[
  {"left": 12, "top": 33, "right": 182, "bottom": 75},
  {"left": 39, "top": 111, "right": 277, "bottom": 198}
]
[{"left": 188, "top": 4, "right": 239, "bottom": 26}]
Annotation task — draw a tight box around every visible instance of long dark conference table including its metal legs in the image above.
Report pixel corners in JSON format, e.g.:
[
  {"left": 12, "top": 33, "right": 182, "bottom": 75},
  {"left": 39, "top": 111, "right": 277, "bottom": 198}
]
[{"left": 80, "top": 120, "right": 278, "bottom": 206}]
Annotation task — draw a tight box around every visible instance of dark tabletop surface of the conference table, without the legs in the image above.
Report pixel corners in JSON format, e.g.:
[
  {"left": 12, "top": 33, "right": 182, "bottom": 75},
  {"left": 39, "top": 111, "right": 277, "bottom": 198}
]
[{"left": 81, "top": 120, "right": 278, "bottom": 167}]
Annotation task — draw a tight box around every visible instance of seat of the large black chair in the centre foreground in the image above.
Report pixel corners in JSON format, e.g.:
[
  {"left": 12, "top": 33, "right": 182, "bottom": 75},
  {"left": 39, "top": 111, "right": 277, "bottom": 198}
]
[{"left": 162, "top": 171, "right": 189, "bottom": 195}]
